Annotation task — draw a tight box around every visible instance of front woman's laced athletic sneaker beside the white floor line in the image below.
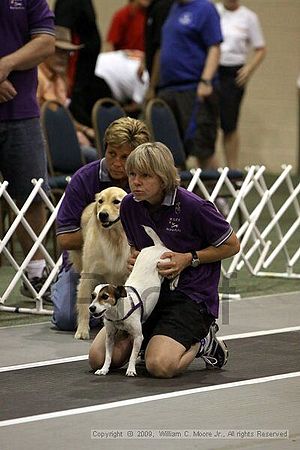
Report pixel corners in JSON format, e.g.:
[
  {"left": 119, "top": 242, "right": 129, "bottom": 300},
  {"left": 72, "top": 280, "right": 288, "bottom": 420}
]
[{"left": 196, "top": 322, "right": 228, "bottom": 369}]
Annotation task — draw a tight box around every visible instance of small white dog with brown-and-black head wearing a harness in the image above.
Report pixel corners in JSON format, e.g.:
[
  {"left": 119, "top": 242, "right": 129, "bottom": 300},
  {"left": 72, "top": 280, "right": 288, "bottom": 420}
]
[{"left": 90, "top": 226, "right": 178, "bottom": 377}]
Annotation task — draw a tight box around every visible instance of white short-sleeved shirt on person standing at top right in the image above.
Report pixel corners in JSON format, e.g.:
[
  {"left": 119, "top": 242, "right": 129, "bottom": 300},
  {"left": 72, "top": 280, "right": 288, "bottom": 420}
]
[{"left": 216, "top": 3, "right": 265, "bottom": 66}]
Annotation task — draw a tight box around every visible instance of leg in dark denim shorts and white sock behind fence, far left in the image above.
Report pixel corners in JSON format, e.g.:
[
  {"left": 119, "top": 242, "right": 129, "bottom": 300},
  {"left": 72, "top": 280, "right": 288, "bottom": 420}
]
[{"left": 1, "top": 118, "right": 50, "bottom": 286}]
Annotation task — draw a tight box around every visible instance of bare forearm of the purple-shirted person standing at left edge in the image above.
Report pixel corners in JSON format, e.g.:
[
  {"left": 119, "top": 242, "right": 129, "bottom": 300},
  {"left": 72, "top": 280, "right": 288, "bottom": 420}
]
[{"left": 0, "top": 34, "right": 55, "bottom": 83}]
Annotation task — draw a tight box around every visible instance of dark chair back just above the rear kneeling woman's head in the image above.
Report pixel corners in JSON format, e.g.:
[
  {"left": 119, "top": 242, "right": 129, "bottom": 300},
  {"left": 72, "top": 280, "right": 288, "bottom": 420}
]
[{"left": 92, "top": 97, "right": 126, "bottom": 158}]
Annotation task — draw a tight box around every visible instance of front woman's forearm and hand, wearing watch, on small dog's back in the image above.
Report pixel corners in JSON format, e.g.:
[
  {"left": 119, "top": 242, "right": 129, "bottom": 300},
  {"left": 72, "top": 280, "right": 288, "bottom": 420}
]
[{"left": 158, "top": 232, "right": 240, "bottom": 277}]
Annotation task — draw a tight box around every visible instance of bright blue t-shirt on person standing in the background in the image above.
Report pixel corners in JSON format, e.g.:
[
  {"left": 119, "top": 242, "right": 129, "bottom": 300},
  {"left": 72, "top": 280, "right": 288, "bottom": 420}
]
[{"left": 160, "top": 0, "right": 222, "bottom": 90}]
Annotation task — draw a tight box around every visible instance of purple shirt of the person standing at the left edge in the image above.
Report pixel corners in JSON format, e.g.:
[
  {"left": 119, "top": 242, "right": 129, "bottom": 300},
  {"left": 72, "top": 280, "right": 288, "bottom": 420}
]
[{"left": 0, "top": 0, "right": 55, "bottom": 121}]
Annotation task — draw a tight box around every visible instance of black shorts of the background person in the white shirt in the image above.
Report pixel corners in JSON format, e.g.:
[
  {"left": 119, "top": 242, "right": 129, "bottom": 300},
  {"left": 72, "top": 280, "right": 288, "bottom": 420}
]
[{"left": 219, "top": 66, "right": 245, "bottom": 133}]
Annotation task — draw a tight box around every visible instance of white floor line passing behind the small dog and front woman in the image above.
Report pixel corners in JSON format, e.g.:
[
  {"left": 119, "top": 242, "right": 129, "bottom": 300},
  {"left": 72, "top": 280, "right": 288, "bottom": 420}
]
[{"left": 0, "top": 326, "right": 300, "bottom": 373}]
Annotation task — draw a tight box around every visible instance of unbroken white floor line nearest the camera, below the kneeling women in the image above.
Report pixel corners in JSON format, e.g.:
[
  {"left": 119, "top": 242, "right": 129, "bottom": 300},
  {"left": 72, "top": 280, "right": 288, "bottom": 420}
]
[{"left": 0, "top": 372, "right": 300, "bottom": 427}]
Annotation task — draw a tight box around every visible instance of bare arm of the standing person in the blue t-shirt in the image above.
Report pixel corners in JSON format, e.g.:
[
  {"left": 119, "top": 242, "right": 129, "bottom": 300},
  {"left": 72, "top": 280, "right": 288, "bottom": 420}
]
[{"left": 197, "top": 44, "right": 221, "bottom": 99}]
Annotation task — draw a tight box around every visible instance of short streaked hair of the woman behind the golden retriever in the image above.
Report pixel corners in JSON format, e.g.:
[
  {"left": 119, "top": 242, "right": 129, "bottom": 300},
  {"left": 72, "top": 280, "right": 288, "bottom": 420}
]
[{"left": 104, "top": 117, "right": 150, "bottom": 149}]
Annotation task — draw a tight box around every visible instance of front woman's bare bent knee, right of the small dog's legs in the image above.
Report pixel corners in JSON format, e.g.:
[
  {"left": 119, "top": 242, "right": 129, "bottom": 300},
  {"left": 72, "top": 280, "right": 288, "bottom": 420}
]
[{"left": 145, "top": 335, "right": 200, "bottom": 378}]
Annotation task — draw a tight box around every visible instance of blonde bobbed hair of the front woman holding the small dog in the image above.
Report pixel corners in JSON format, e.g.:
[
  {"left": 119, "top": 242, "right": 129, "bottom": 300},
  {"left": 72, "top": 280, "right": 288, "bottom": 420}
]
[{"left": 126, "top": 142, "right": 180, "bottom": 191}]
